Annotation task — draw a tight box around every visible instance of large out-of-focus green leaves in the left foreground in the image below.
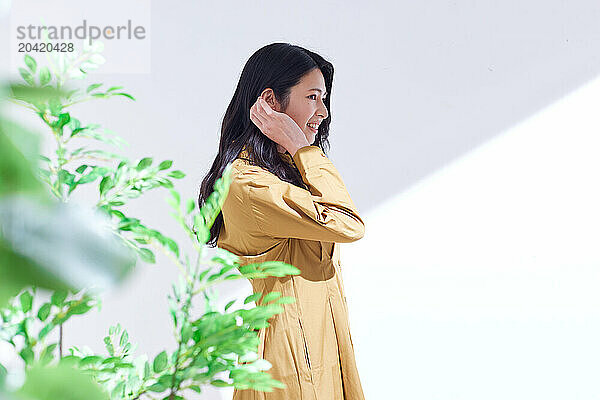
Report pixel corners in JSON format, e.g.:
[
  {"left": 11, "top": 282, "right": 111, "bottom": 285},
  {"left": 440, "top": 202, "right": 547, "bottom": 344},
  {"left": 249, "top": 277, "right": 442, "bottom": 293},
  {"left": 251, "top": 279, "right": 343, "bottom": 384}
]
[{"left": 0, "top": 85, "right": 133, "bottom": 400}]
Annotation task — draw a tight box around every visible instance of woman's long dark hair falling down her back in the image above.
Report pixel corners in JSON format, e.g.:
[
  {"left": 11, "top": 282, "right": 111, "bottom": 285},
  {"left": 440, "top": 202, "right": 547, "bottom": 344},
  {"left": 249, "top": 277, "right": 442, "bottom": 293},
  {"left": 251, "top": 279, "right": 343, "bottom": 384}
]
[{"left": 198, "top": 43, "right": 333, "bottom": 247}]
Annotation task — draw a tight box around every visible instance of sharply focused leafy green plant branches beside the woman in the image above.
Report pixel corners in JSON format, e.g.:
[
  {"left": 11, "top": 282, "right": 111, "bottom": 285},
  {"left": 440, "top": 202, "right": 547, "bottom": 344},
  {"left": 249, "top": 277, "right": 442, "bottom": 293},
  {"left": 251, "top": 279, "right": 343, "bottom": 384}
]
[{"left": 0, "top": 46, "right": 299, "bottom": 399}]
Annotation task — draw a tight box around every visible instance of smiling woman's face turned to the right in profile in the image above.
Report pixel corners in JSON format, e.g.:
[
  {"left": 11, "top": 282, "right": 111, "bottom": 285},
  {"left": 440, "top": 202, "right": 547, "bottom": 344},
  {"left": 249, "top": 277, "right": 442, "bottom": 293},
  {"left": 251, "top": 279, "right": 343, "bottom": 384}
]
[{"left": 276, "top": 68, "right": 329, "bottom": 144}]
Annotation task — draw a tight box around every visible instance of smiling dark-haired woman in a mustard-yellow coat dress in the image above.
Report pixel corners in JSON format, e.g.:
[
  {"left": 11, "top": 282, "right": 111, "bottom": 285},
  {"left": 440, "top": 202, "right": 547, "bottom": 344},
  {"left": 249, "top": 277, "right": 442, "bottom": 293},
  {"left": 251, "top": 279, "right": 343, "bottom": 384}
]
[{"left": 199, "top": 43, "right": 364, "bottom": 400}]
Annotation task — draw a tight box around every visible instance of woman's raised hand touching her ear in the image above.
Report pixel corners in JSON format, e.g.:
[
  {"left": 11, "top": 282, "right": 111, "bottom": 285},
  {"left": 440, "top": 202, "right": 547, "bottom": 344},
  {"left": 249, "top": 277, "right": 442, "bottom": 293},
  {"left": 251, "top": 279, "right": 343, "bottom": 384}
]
[{"left": 250, "top": 97, "right": 310, "bottom": 156}]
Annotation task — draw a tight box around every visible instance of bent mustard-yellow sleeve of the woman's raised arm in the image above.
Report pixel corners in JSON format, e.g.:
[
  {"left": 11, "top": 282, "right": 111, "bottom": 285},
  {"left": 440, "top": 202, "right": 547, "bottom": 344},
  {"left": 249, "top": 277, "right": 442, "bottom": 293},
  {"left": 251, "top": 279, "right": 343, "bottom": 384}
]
[{"left": 234, "top": 146, "right": 365, "bottom": 243}]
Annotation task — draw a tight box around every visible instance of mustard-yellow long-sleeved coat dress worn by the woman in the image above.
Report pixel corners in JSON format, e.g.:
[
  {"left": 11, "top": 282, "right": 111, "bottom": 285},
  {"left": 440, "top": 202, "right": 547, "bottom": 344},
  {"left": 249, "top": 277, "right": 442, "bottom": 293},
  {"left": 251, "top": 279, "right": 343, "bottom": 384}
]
[{"left": 217, "top": 146, "right": 365, "bottom": 400}]
